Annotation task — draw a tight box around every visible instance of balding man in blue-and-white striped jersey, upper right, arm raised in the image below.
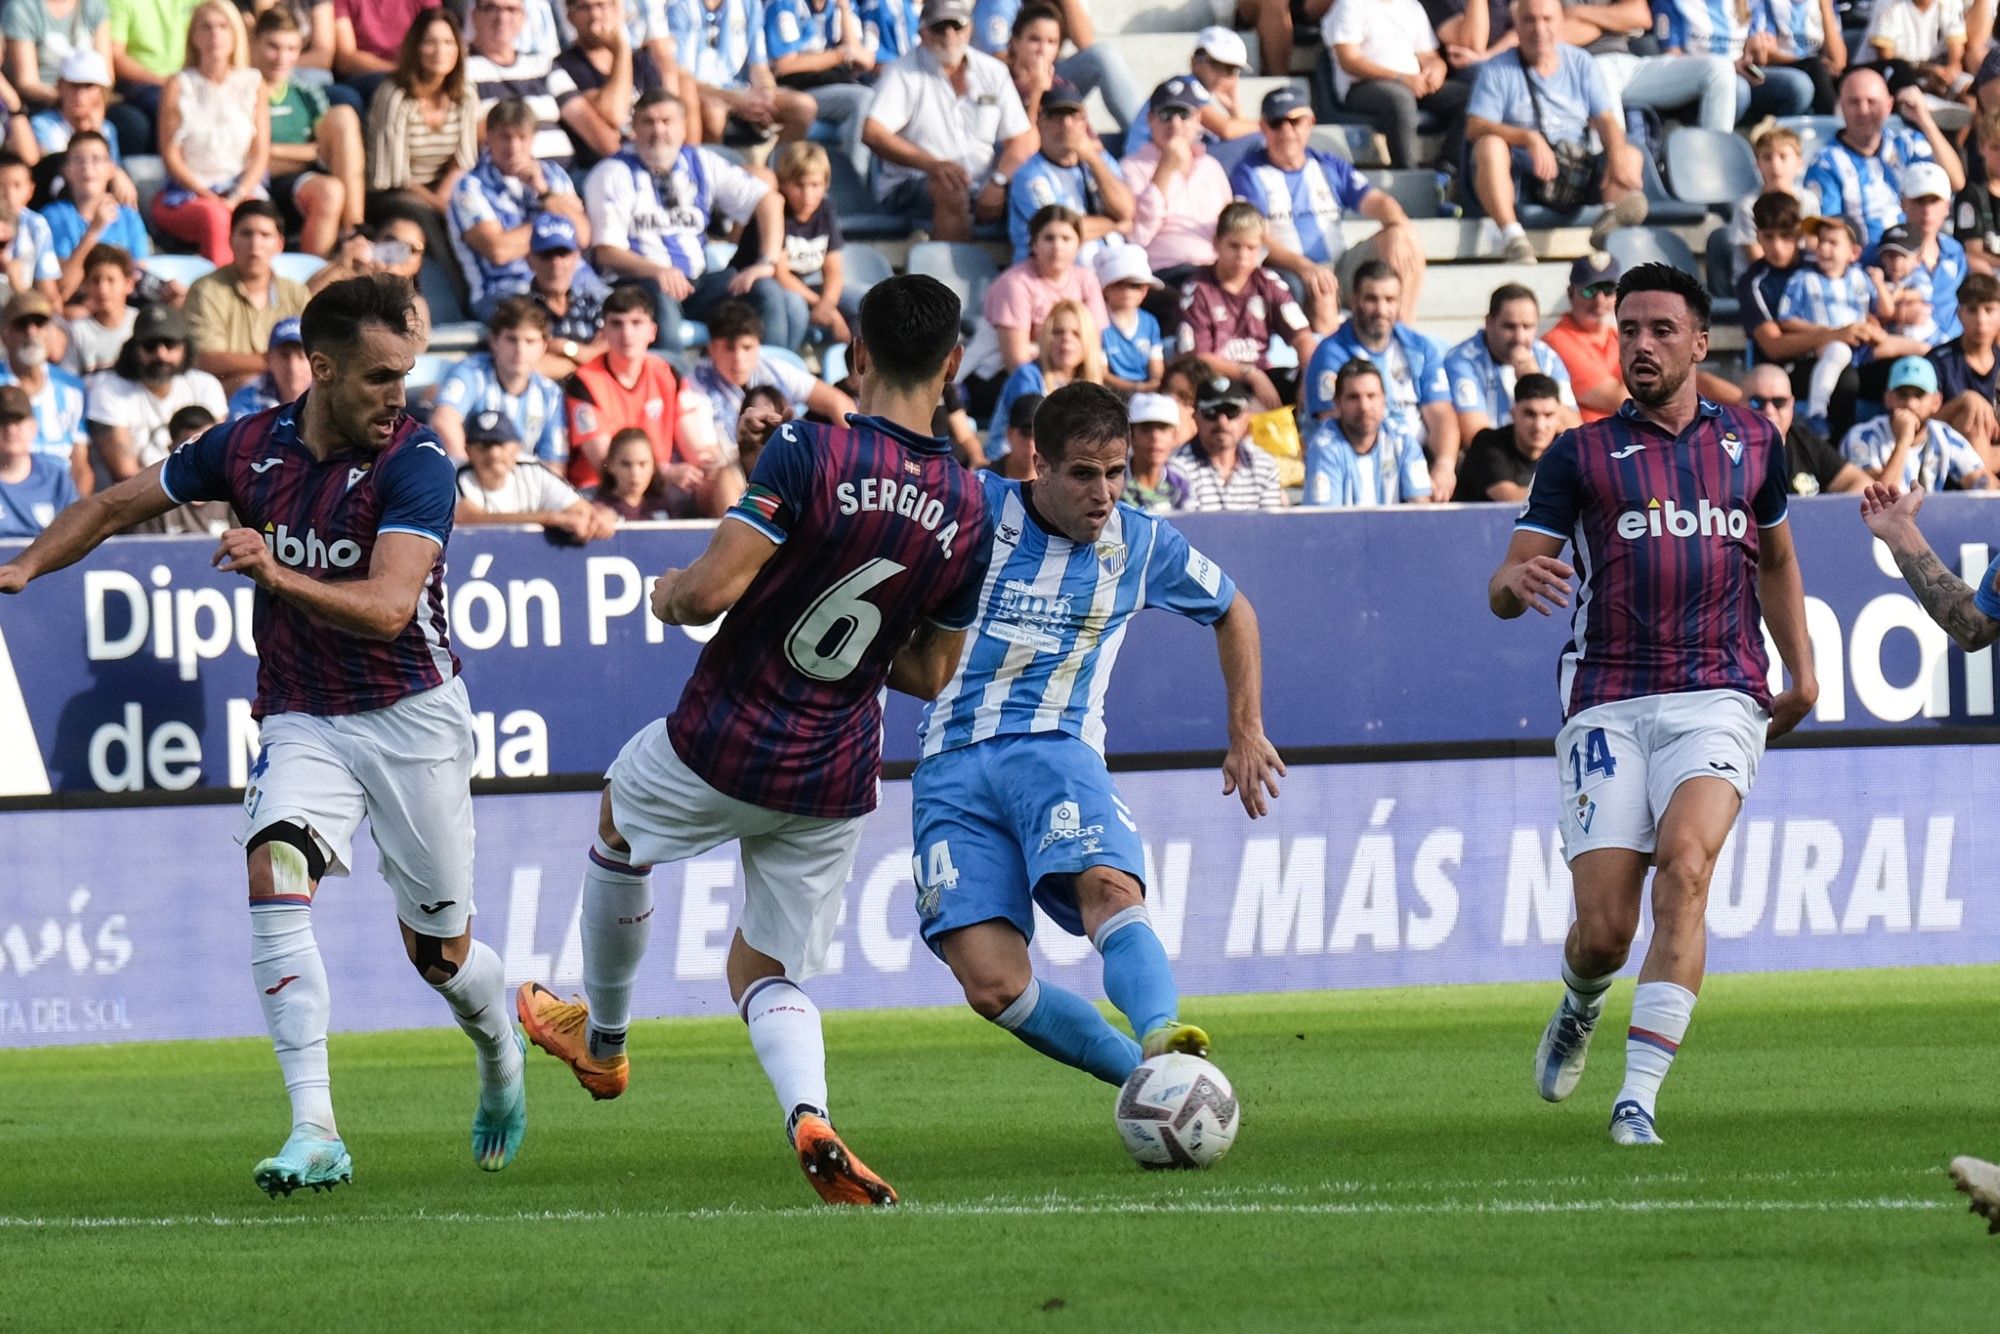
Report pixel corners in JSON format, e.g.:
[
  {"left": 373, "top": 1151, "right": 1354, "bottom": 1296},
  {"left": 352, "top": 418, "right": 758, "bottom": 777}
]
[{"left": 1806, "top": 66, "right": 1966, "bottom": 246}]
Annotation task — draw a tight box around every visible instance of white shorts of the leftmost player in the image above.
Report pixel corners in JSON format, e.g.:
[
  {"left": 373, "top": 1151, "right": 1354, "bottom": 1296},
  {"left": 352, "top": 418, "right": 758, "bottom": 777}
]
[{"left": 236, "top": 676, "right": 474, "bottom": 940}]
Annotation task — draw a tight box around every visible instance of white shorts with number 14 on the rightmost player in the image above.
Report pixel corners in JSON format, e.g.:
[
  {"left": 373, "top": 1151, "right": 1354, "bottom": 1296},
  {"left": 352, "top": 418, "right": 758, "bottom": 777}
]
[{"left": 1556, "top": 690, "right": 1770, "bottom": 862}]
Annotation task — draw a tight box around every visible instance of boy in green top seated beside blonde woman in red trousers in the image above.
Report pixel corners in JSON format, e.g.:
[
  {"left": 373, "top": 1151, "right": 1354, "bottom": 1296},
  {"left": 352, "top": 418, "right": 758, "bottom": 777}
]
[{"left": 250, "top": 4, "right": 368, "bottom": 258}]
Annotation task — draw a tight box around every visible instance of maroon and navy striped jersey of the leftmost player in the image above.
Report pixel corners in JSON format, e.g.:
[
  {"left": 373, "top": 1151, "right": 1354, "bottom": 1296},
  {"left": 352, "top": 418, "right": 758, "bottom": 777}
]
[{"left": 160, "top": 398, "right": 458, "bottom": 718}]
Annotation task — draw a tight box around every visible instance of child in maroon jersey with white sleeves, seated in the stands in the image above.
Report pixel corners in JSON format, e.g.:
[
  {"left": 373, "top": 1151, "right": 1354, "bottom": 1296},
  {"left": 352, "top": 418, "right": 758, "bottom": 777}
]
[{"left": 1176, "top": 200, "right": 1314, "bottom": 410}]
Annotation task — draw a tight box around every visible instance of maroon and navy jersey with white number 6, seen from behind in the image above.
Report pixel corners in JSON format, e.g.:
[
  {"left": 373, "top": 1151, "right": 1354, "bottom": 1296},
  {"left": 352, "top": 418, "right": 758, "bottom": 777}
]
[{"left": 666, "top": 416, "right": 992, "bottom": 818}]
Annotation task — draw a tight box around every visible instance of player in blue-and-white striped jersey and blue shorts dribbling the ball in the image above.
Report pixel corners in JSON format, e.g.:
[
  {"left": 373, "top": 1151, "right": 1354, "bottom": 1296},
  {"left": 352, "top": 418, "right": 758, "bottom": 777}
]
[{"left": 912, "top": 382, "right": 1284, "bottom": 1084}]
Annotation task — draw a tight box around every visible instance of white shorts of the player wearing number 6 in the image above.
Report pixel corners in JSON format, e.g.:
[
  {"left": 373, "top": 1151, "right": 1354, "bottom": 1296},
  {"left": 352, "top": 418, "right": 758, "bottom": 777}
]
[{"left": 606, "top": 718, "right": 862, "bottom": 982}]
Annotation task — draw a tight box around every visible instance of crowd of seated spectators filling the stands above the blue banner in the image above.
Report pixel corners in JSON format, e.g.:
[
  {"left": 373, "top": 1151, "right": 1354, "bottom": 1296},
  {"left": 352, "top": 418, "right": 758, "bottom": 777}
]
[{"left": 0, "top": 0, "right": 2000, "bottom": 542}]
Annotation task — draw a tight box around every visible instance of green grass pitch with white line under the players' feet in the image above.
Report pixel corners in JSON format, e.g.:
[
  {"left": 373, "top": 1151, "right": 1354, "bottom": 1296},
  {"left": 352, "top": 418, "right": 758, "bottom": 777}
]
[{"left": 0, "top": 968, "right": 2000, "bottom": 1334}]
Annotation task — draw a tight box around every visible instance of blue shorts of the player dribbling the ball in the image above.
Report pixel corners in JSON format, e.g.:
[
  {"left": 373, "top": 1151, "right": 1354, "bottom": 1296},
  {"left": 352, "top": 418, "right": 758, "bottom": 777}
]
[{"left": 912, "top": 732, "right": 1146, "bottom": 956}]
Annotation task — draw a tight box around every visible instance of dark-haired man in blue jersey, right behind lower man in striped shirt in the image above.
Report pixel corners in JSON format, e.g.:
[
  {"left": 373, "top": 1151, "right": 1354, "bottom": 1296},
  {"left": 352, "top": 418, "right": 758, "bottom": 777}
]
[{"left": 1300, "top": 260, "right": 1458, "bottom": 502}]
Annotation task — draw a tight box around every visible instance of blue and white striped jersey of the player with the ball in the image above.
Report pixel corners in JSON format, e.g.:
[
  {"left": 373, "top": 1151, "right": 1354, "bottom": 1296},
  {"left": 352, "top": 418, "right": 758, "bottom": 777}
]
[{"left": 922, "top": 472, "right": 1236, "bottom": 758}]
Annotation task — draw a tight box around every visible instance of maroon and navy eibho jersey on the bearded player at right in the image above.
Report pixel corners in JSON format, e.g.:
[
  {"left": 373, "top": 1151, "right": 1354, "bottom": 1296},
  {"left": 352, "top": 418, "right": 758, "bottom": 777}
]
[{"left": 1516, "top": 398, "right": 1786, "bottom": 718}]
